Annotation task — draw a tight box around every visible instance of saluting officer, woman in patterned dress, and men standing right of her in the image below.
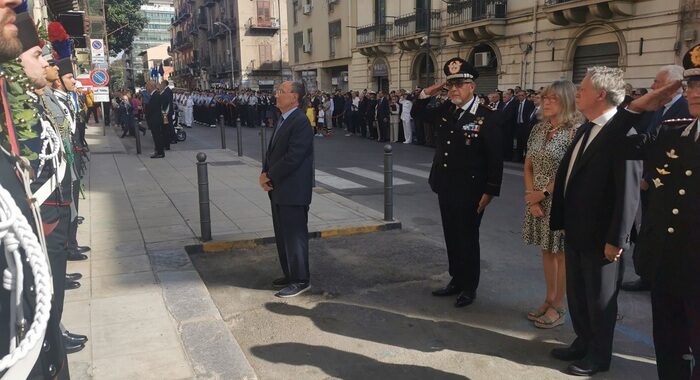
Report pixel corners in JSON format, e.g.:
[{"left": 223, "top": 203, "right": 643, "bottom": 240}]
[{"left": 412, "top": 45, "right": 700, "bottom": 379}]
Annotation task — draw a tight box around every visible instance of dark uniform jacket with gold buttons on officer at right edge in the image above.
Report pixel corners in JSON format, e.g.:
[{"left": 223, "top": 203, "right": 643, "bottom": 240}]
[{"left": 637, "top": 119, "right": 700, "bottom": 297}]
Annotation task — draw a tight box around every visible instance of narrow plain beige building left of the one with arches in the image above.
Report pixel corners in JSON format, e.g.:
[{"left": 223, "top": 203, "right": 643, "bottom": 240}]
[{"left": 287, "top": 0, "right": 358, "bottom": 90}]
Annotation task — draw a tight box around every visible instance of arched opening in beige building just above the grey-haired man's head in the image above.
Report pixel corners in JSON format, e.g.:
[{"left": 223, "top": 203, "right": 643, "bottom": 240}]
[{"left": 571, "top": 27, "right": 620, "bottom": 83}]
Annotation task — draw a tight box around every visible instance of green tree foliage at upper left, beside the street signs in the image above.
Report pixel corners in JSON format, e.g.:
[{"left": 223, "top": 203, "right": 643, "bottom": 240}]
[{"left": 105, "top": 0, "right": 148, "bottom": 55}]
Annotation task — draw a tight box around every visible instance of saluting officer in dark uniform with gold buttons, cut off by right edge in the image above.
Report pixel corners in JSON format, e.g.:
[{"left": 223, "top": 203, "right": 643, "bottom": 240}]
[{"left": 620, "top": 44, "right": 700, "bottom": 380}]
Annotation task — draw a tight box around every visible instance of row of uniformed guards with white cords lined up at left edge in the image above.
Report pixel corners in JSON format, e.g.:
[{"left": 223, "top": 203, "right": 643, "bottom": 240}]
[{"left": 0, "top": 9, "right": 94, "bottom": 379}]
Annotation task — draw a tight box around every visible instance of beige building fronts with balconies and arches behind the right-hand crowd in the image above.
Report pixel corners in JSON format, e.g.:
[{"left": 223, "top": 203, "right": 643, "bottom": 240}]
[{"left": 298, "top": 0, "right": 700, "bottom": 93}]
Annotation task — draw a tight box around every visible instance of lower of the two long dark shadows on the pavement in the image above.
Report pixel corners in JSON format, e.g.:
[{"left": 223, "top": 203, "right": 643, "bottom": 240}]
[{"left": 250, "top": 343, "right": 468, "bottom": 380}]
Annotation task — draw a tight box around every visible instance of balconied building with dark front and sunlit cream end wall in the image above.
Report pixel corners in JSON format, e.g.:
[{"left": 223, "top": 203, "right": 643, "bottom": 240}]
[{"left": 171, "top": 0, "right": 291, "bottom": 91}]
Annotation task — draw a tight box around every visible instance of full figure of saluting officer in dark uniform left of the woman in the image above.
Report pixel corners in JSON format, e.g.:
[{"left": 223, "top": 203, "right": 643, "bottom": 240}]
[{"left": 411, "top": 58, "right": 503, "bottom": 307}]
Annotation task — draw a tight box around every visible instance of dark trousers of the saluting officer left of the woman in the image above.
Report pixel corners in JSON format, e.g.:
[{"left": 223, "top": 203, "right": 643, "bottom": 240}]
[{"left": 438, "top": 189, "right": 483, "bottom": 292}]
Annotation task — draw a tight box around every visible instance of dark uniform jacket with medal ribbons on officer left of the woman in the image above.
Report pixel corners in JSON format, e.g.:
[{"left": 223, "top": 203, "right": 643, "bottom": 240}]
[{"left": 411, "top": 97, "right": 503, "bottom": 196}]
